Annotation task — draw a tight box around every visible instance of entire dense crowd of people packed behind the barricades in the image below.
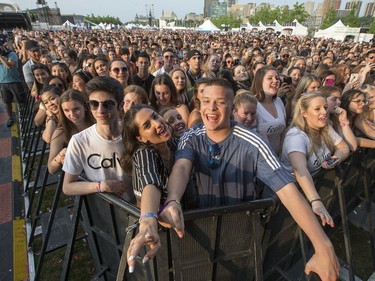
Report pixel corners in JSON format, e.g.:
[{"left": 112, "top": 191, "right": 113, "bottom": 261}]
[{"left": 0, "top": 26, "right": 375, "bottom": 280}]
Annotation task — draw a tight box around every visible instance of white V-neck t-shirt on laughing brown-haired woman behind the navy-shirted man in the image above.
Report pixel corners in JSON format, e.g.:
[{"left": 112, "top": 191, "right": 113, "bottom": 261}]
[{"left": 257, "top": 97, "right": 286, "bottom": 153}]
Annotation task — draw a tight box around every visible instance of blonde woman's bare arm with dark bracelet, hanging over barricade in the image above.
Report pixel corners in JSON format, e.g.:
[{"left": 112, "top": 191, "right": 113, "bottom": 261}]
[{"left": 288, "top": 151, "right": 334, "bottom": 227}]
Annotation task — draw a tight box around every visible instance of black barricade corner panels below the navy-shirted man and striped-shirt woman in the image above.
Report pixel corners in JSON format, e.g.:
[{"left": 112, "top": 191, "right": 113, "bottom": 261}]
[{"left": 61, "top": 189, "right": 274, "bottom": 280}]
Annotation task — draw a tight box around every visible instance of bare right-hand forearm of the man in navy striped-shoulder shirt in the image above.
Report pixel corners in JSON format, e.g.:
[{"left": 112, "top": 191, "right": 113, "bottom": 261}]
[{"left": 276, "top": 183, "right": 340, "bottom": 281}]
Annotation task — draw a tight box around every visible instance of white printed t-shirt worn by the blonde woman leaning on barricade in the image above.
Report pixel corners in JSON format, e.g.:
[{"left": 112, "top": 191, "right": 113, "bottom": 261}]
[{"left": 281, "top": 125, "right": 342, "bottom": 175}]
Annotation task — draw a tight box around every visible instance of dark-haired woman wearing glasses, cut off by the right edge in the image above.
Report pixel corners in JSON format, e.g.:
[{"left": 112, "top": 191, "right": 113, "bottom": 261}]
[{"left": 341, "top": 89, "right": 375, "bottom": 148}]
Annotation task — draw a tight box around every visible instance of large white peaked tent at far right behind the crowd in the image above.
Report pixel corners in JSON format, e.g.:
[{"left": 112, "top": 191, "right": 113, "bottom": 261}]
[{"left": 314, "top": 20, "right": 373, "bottom": 42}]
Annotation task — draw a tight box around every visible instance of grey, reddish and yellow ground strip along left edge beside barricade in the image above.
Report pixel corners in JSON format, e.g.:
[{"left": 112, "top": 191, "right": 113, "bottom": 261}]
[{"left": 0, "top": 104, "right": 28, "bottom": 281}]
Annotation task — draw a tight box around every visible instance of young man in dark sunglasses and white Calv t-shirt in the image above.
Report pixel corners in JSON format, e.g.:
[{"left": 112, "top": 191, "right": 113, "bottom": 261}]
[{"left": 62, "top": 77, "right": 135, "bottom": 202}]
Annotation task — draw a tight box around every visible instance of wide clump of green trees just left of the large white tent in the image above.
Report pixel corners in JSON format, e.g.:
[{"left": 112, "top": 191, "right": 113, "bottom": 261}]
[{"left": 249, "top": 2, "right": 309, "bottom": 24}]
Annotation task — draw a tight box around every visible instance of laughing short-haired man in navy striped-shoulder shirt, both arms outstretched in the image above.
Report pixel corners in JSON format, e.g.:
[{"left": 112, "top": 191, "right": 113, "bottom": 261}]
[{"left": 153, "top": 79, "right": 340, "bottom": 281}]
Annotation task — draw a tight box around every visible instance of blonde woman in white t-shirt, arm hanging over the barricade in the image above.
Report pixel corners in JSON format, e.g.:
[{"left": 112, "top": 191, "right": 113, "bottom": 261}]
[{"left": 281, "top": 93, "right": 349, "bottom": 227}]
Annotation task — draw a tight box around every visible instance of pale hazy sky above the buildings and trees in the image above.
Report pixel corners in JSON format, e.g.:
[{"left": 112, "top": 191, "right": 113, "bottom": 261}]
[{"left": 6, "top": 0, "right": 374, "bottom": 22}]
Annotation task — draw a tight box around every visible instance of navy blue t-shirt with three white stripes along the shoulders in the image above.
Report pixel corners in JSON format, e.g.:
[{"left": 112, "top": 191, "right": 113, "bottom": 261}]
[{"left": 176, "top": 121, "right": 293, "bottom": 207}]
